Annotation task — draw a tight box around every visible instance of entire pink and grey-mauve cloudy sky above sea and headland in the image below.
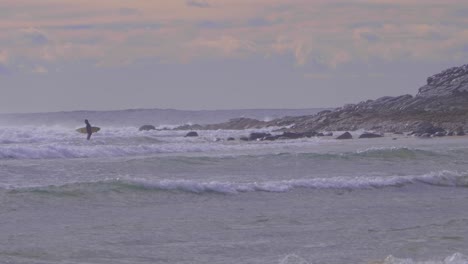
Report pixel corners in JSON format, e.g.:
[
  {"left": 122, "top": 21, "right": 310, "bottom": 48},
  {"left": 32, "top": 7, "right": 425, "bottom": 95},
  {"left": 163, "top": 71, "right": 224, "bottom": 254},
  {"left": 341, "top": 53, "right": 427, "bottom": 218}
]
[{"left": 0, "top": 0, "right": 468, "bottom": 113}]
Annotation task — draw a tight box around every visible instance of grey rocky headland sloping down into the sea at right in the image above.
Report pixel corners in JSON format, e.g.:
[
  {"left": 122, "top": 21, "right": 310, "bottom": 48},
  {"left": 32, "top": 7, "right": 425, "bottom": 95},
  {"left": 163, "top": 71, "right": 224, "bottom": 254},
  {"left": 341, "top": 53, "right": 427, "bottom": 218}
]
[{"left": 177, "top": 64, "right": 468, "bottom": 136}]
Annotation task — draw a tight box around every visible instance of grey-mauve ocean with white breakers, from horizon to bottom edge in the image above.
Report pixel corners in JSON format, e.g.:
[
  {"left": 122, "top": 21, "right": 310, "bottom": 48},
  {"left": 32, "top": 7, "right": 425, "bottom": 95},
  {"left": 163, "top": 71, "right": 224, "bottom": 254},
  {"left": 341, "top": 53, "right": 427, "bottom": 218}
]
[{"left": 0, "top": 109, "right": 468, "bottom": 264}]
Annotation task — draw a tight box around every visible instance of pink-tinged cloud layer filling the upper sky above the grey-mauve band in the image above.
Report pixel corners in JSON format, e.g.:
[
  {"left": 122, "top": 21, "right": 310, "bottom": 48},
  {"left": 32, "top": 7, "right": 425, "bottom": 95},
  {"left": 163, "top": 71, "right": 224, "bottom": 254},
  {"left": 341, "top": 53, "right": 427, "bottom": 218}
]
[{"left": 0, "top": 0, "right": 468, "bottom": 68}]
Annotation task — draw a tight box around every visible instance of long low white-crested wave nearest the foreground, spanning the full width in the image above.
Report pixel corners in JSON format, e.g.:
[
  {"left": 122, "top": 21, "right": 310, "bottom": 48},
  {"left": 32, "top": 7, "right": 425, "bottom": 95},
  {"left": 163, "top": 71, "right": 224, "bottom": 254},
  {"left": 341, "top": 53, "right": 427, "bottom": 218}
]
[{"left": 4, "top": 171, "right": 468, "bottom": 194}]
